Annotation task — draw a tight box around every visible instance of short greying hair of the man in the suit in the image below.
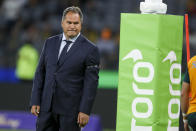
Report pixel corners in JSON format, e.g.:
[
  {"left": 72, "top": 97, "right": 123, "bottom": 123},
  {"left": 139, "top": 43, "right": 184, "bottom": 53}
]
[{"left": 62, "top": 6, "right": 83, "bottom": 23}]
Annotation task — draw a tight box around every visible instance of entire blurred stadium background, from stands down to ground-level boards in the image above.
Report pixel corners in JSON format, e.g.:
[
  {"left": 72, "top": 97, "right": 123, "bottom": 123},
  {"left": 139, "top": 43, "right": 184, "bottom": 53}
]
[{"left": 0, "top": 0, "right": 193, "bottom": 131}]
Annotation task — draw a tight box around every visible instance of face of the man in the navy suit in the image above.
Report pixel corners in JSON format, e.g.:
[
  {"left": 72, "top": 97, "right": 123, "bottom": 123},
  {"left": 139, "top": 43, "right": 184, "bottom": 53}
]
[{"left": 61, "top": 12, "right": 82, "bottom": 39}]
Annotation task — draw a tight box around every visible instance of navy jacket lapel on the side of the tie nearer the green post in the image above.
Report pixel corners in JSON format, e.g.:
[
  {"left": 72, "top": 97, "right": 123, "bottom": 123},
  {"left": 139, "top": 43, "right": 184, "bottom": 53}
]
[{"left": 59, "top": 35, "right": 82, "bottom": 66}]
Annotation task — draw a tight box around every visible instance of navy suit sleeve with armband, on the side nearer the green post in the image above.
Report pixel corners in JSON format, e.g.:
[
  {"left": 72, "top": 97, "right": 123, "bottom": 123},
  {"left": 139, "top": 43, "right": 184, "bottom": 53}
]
[{"left": 80, "top": 47, "right": 100, "bottom": 115}]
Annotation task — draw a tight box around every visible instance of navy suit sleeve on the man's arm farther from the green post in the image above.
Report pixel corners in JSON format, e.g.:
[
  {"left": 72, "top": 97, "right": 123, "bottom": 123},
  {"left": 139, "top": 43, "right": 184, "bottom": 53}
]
[{"left": 30, "top": 40, "right": 47, "bottom": 106}]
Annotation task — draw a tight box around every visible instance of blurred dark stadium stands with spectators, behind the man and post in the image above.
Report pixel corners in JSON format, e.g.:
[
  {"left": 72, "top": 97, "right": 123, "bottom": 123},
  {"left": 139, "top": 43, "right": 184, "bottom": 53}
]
[{"left": 0, "top": 0, "right": 193, "bottom": 75}]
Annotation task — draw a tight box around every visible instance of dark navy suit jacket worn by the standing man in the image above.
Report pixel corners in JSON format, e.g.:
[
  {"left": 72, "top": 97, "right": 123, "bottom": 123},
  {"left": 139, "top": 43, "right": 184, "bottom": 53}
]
[{"left": 30, "top": 34, "right": 99, "bottom": 115}]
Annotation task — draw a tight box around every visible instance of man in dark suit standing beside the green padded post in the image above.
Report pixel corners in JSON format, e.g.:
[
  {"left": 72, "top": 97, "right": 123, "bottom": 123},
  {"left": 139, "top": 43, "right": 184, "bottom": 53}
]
[{"left": 30, "top": 6, "right": 99, "bottom": 131}]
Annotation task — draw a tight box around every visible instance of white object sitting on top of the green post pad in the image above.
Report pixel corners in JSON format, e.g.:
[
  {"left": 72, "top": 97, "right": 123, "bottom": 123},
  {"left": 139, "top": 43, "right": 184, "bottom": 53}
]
[{"left": 140, "top": 0, "right": 167, "bottom": 14}]
